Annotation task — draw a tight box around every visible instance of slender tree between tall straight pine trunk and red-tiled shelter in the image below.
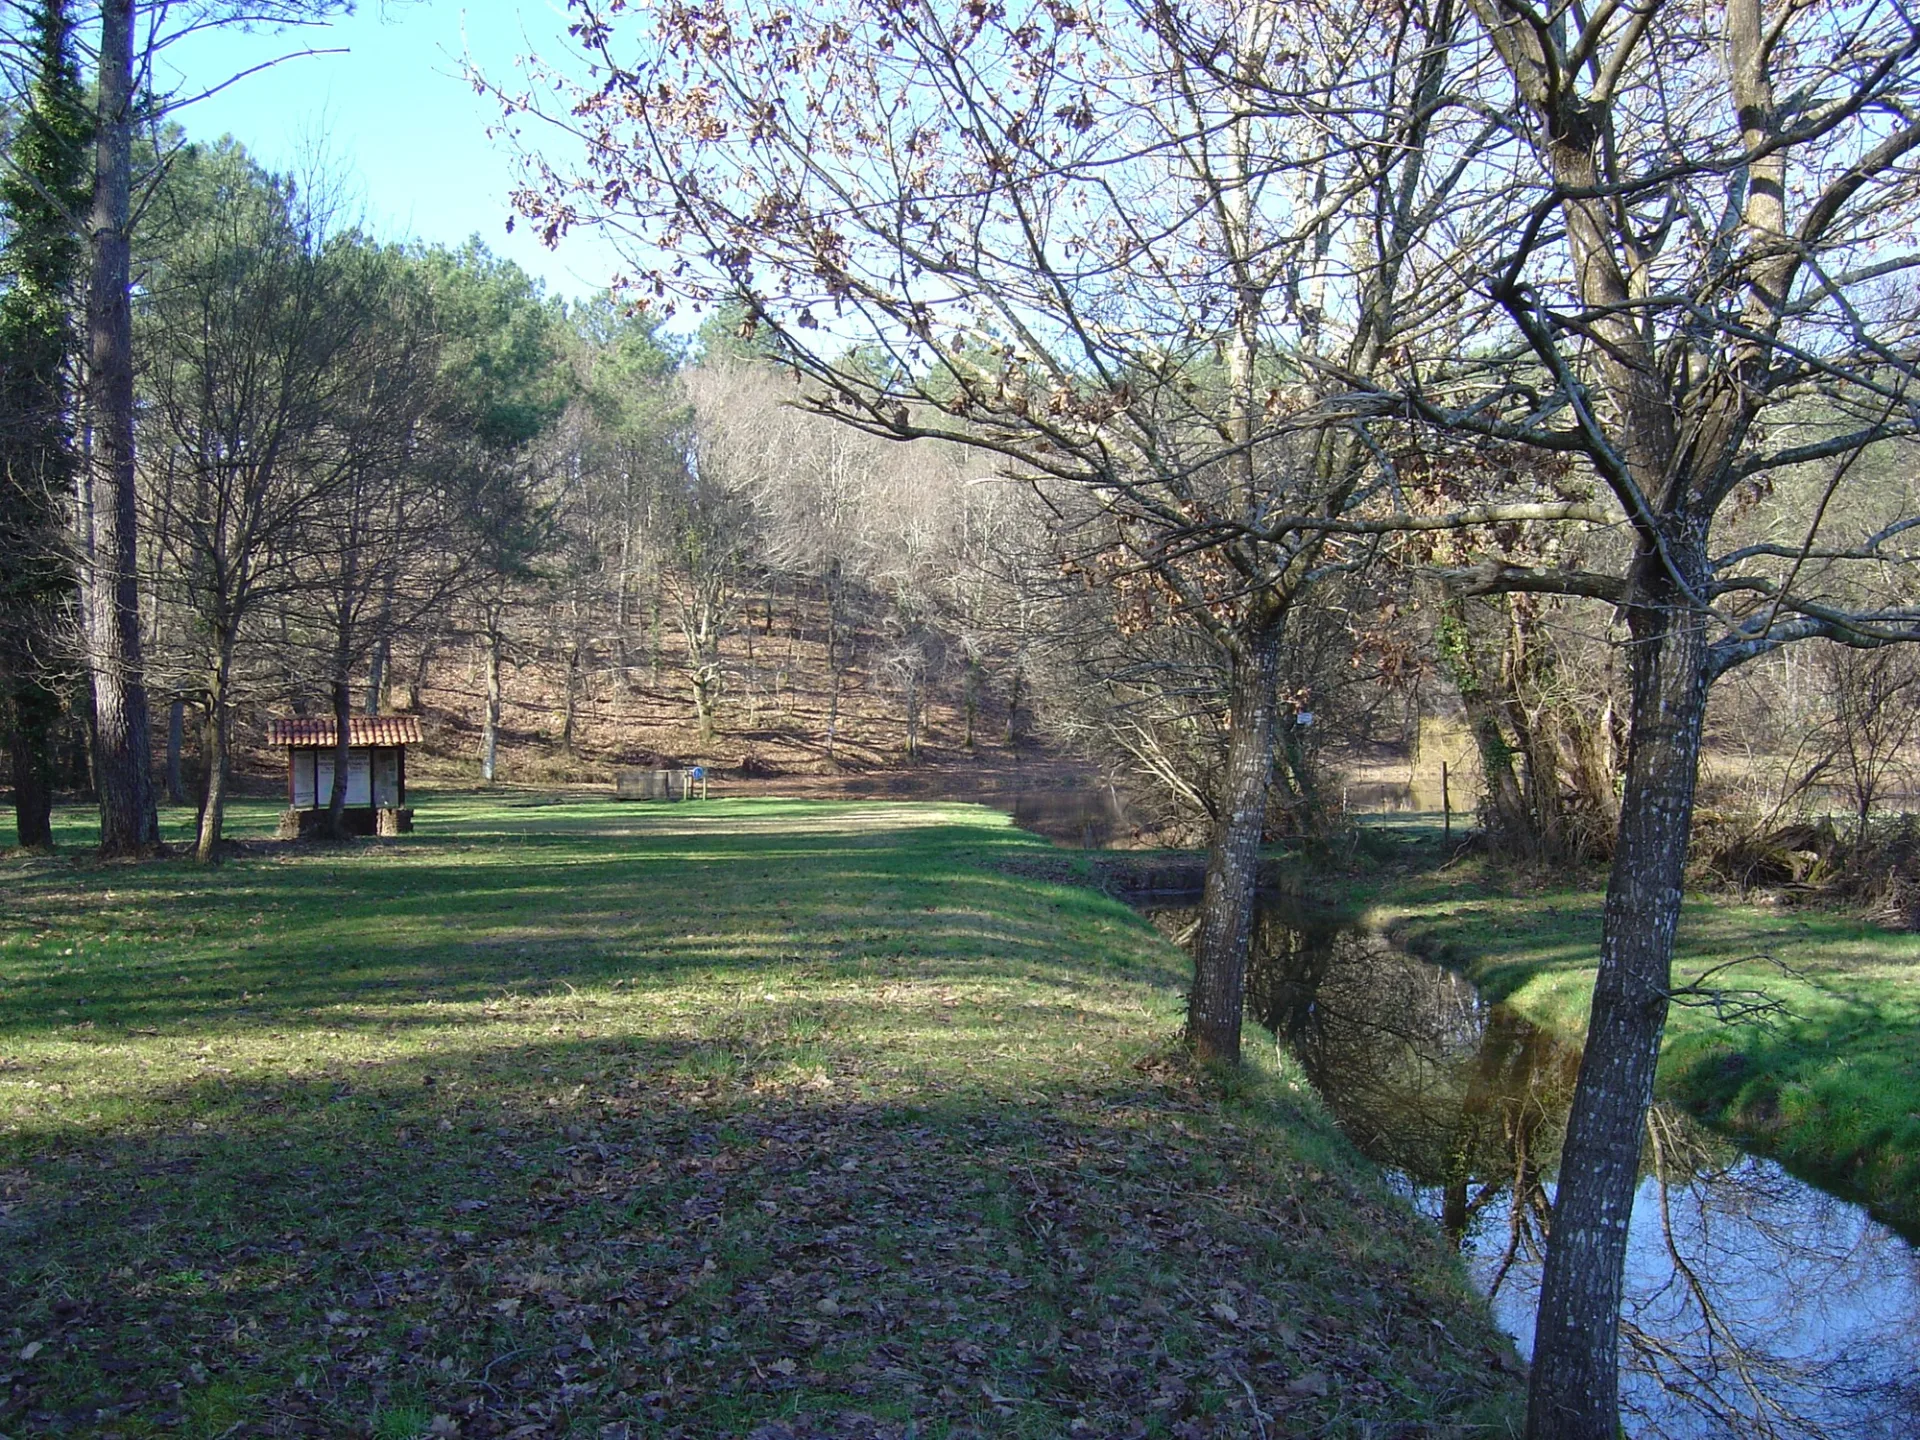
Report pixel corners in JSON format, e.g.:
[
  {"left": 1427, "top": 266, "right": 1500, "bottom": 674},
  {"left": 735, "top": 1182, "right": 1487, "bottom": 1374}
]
[{"left": 142, "top": 146, "right": 369, "bottom": 860}]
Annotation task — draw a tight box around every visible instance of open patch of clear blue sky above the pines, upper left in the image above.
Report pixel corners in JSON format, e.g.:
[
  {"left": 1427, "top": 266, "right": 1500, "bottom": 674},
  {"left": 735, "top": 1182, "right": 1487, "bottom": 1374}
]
[{"left": 157, "top": 0, "right": 618, "bottom": 296}]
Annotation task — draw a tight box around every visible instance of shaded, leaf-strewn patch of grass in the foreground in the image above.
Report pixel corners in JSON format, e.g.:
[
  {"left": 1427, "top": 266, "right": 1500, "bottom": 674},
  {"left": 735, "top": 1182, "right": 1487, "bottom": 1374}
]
[{"left": 0, "top": 1041, "right": 1511, "bottom": 1438}]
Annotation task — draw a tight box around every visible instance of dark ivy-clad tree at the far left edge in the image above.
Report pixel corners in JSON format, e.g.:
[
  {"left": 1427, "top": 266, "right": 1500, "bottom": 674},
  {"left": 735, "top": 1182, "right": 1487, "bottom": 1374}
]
[{"left": 0, "top": 0, "right": 92, "bottom": 847}]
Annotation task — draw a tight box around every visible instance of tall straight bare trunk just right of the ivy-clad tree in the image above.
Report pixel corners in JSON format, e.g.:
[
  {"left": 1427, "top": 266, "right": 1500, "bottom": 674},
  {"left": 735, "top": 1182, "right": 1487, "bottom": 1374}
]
[{"left": 83, "top": 0, "right": 159, "bottom": 854}]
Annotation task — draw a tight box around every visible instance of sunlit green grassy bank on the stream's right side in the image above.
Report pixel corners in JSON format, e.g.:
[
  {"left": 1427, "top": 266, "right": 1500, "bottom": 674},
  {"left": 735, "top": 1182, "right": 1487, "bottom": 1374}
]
[{"left": 1375, "top": 852, "right": 1920, "bottom": 1233}]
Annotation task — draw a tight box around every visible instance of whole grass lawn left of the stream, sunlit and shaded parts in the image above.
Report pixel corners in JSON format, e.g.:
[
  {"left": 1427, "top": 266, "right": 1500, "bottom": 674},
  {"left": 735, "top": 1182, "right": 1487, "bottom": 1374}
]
[{"left": 0, "top": 797, "right": 1515, "bottom": 1440}]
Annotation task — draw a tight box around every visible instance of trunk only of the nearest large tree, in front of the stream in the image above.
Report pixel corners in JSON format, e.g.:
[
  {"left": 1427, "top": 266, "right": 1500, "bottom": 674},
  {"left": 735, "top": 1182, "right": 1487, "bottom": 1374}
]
[{"left": 1526, "top": 547, "right": 1707, "bottom": 1440}]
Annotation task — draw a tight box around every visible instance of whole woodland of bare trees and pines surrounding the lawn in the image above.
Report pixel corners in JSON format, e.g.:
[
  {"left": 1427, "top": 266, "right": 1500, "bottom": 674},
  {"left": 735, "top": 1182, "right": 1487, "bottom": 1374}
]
[{"left": 0, "top": 0, "right": 1920, "bottom": 1440}]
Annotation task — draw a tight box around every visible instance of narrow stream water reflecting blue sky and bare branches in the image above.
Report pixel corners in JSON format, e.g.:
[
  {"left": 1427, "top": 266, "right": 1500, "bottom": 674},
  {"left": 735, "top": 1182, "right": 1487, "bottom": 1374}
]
[{"left": 1148, "top": 902, "right": 1920, "bottom": 1440}]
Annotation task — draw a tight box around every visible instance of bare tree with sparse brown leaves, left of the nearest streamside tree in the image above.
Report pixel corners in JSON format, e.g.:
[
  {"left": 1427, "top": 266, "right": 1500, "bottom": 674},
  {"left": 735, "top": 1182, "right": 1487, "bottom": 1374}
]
[{"left": 491, "top": 0, "right": 1563, "bottom": 1060}]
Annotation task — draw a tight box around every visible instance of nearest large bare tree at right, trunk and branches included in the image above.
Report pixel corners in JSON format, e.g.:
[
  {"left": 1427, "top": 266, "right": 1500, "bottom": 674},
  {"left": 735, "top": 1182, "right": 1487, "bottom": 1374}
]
[{"left": 1382, "top": 0, "right": 1920, "bottom": 1440}]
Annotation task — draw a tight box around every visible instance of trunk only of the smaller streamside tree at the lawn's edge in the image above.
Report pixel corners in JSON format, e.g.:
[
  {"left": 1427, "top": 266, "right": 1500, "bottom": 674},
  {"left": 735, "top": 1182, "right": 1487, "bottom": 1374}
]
[{"left": 1187, "top": 616, "right": 1283, "bottom": 1064}]
